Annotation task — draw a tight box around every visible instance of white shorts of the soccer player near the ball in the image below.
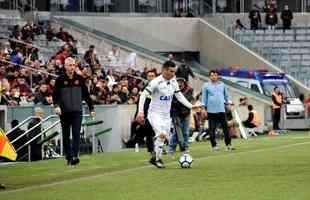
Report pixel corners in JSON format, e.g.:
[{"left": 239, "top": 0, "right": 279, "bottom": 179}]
[{"left": 148, "top": 113, "right": 171, "bottom": 138}]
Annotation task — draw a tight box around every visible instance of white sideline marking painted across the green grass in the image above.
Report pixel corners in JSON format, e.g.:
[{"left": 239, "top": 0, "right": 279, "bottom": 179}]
[{"left": 0, "top": 142, "right": 310, "bottom": 195}]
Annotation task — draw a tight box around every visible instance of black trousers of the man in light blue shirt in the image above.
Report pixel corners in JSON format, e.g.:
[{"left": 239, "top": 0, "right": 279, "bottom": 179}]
[{"left": 208, "top": 112, "right": 231, "bottom": 147}]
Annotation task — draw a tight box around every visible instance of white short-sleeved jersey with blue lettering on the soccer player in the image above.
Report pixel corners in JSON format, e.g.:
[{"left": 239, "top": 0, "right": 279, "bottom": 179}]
[{"left": 145, "top": 75, "right": 180, "bottom": 118}]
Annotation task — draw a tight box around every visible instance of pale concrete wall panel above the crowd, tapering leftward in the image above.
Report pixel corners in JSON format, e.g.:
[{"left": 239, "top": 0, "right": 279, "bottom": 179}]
[{"left": 61, "top": 16, "right": 199, "bottom": 52}]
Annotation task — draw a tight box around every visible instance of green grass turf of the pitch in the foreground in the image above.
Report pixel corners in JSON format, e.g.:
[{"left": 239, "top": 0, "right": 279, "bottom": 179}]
[{"left": 0, "top": 133, "right": 310, "bottom": 200}]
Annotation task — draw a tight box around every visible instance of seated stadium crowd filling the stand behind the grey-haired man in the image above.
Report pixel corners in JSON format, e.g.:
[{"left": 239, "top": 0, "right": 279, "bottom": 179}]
[{"left": 0, "top": 22, "right": 157, "bottom": 106}]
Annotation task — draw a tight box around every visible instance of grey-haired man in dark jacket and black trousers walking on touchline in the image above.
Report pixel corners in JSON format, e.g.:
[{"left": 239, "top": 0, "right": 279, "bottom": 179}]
[{"left": 53, "top": 57, "right": 95, "bottom": 165}]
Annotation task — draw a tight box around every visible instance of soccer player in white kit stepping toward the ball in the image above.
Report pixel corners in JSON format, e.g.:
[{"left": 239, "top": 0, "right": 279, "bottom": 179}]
[{"left": 136, "top": 61, "right": 193, "bottom": 168}]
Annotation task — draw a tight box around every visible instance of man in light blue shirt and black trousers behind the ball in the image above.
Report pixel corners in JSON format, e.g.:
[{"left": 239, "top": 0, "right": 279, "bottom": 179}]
[{"left": 202, "top": 70, "right": 234, "bottom": 151}]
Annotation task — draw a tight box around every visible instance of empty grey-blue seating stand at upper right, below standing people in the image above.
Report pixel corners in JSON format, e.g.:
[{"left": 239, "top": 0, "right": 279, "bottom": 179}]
[{"left": 234, "top": 27, "right": 310, "bottom": 87}]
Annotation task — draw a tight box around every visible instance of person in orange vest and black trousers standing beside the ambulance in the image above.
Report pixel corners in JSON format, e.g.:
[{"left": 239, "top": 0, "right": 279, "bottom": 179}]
[{"left": 272, "top": 86, "right": 283, "bottom": 130}]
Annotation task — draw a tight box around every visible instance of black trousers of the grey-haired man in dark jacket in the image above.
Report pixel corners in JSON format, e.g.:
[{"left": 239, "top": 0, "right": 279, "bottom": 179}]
[{"left": 60, "top": 112, "right": 82, "bottom": 160}]
